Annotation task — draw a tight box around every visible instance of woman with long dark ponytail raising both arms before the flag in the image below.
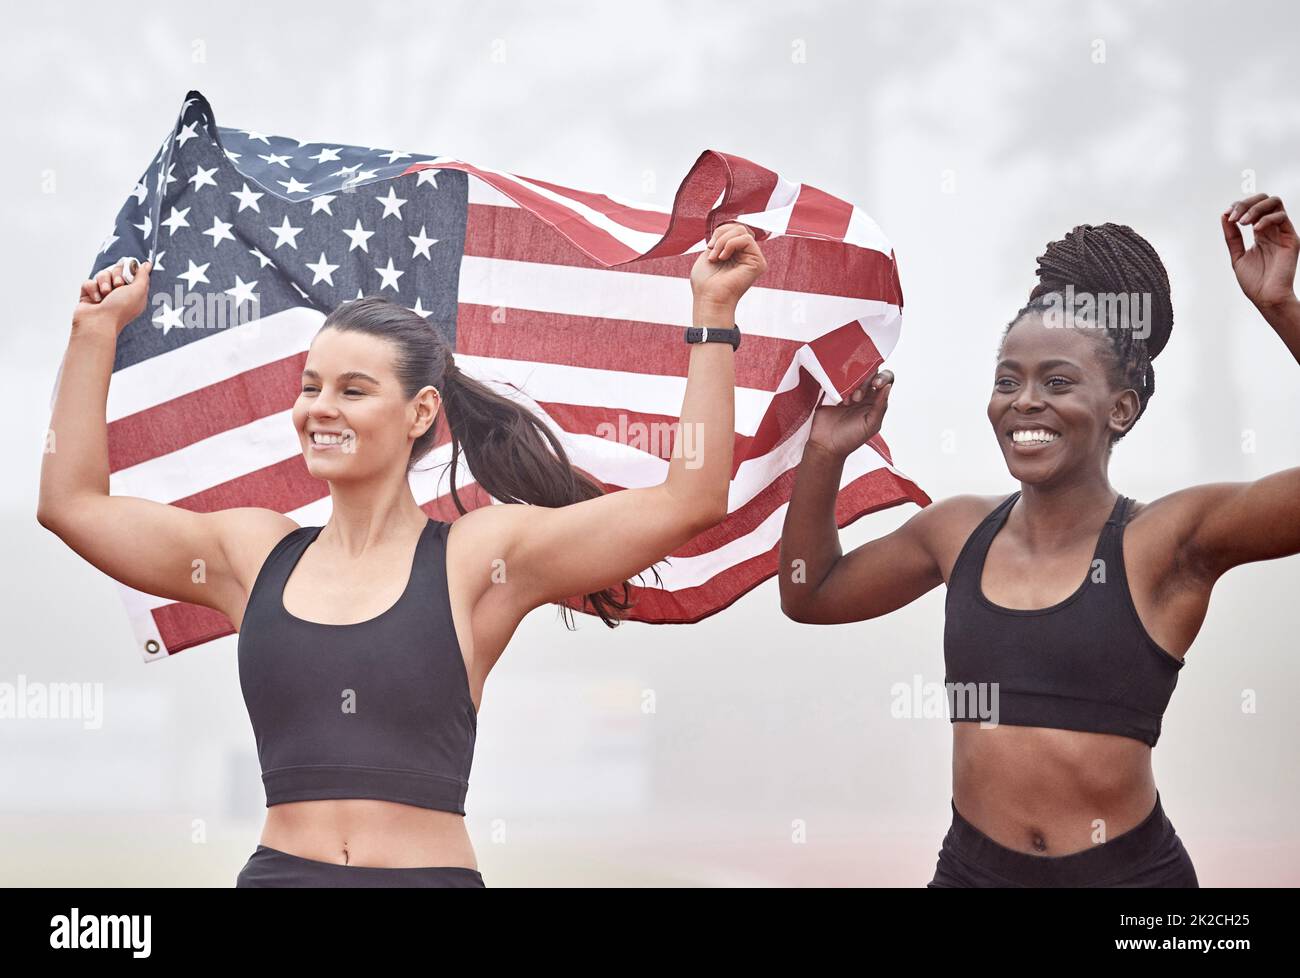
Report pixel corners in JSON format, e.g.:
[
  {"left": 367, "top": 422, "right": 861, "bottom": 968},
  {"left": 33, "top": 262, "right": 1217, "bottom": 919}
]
[{"left": 38, "top": 224, "right": 766, "bottom": 887}]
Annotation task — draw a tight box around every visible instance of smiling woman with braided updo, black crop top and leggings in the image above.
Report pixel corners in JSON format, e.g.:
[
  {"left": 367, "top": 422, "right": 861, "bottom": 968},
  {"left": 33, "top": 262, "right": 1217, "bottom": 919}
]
[{"left": 780, "top": 194, "right": 1300, "bottom": 887}]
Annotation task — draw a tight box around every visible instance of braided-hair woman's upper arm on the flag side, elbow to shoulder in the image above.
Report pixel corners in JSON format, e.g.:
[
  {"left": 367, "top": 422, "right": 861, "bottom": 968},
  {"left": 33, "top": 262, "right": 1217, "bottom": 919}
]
[{"left": 794, "top": 503, "right": 944, "bottom": 624}]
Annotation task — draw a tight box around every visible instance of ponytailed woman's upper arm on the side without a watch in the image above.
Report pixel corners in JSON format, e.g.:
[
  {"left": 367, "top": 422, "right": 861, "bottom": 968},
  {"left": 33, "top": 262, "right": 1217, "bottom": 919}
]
[{"left": 42, "top": 494, "right": 296, "bottom": 610}]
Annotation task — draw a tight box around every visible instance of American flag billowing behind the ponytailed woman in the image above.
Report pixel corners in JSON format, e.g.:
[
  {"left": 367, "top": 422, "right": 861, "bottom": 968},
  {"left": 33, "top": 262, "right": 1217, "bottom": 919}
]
[{"left": 81, "top": 91, "right": 930, "bottom": 661}]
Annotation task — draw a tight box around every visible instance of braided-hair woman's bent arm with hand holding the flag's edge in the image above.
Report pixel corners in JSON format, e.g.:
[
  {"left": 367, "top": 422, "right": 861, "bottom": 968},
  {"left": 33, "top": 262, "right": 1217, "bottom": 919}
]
[{"left": 777, "top": 371, "right": 944, "bottom": 624}]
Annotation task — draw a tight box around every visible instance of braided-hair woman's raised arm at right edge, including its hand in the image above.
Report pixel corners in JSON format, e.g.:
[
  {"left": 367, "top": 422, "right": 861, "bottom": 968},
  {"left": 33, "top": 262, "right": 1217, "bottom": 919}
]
[{"left": 1166, "top": 194, "right": 1300, "bottom": 583}]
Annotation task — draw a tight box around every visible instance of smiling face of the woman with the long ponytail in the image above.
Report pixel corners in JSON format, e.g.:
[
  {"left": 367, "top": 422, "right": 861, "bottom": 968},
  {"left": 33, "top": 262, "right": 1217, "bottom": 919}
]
[{"left": 294, "top": 329, "right": 441, "bottom": 480}]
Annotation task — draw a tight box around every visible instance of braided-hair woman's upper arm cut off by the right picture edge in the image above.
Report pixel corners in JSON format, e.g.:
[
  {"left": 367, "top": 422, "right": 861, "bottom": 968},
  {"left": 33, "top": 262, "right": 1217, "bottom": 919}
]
[{"left": 1185, "top": 468, "right": 1300, "bottom": 581}]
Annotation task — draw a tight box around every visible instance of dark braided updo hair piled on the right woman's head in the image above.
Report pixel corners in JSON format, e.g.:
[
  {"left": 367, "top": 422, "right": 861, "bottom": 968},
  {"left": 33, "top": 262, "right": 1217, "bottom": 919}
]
[{"left": 1002, "top": 224, "right": 1174, "bottom": 445}]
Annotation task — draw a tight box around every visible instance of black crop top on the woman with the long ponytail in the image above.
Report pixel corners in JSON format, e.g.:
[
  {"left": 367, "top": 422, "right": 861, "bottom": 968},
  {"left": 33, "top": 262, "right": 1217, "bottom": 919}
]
[{"left": 239, "top": 519, "right": 478, "bottom": 815}]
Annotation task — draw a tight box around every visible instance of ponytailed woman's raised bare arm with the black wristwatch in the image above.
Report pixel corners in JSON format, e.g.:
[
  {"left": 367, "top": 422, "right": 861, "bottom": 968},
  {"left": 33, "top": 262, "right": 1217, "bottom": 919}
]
[{"left": 454, "top": 224, "right": 767, "bottom": 614}]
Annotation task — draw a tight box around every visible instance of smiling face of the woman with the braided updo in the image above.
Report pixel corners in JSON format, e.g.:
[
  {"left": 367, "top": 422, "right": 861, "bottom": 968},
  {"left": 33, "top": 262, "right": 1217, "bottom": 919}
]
[{"left": 988, "top": 312, "right": 1139, "bottom": 485}]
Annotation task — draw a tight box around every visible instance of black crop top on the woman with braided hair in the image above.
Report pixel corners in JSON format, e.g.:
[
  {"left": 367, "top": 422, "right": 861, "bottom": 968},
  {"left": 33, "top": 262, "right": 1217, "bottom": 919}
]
[{"left": 944, "top": 492, "right": 1183, "bottom": 747}]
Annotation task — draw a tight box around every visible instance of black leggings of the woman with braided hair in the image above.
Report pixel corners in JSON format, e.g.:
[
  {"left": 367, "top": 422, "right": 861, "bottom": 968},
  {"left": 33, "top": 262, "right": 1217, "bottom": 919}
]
[{"left": 927, "top": 792, "right": 1200, "bottom": 888}]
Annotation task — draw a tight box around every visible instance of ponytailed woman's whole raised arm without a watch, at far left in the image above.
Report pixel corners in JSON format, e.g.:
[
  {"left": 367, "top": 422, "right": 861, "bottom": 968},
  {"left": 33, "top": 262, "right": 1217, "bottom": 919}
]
[{"left": 36, "top": 261, "right": 296, "bottom": 614}]
